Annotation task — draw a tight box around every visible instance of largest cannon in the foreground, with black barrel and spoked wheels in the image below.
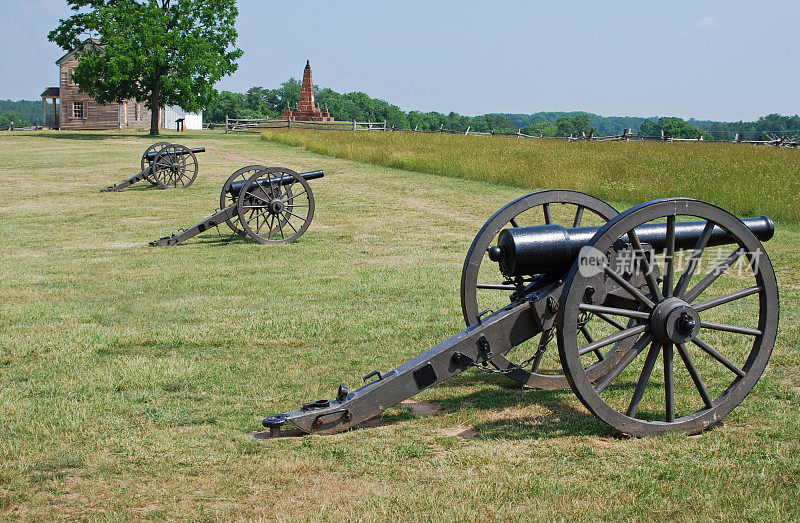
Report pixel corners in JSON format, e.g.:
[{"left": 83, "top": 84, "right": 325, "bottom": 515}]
[{"left": 263, "top": 191, "right": 779, "bottom": 437}]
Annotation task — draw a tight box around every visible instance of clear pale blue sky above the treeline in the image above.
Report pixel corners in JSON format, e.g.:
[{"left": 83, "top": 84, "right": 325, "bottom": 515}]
[{"left": 0, "top": 0, "right": 800, "bottom": 121}]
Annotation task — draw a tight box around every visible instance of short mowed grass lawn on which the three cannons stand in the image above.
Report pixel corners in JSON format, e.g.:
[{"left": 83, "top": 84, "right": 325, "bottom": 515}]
[{"left": 0, "top": 131, "right": 800, "bottom": 521}]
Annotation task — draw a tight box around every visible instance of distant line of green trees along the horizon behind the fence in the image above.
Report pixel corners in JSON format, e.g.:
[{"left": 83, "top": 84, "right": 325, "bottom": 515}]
[{"left": 0, "top": 84, "right": 800, "bottom": 141}]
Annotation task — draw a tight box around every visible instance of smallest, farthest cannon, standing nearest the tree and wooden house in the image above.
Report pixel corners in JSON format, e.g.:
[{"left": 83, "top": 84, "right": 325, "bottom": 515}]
[{"left": 100, "top": 142, "right": 206, "bottom": 192}]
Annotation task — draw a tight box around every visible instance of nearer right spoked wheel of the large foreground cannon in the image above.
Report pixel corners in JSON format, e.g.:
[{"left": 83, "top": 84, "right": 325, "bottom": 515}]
[{"left": 557, "top": 199, "right": 779, "bottom": 436}]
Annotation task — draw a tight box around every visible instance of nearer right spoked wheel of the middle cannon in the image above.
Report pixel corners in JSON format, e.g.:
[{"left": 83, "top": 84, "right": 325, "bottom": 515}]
[{"left": 238, "top": 167, "right": 314, "bottom": 243}]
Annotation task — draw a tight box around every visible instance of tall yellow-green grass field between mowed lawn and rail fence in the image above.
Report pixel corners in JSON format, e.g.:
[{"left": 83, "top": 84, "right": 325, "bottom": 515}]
[{"left": 262, "top": 130, "right": 800, "bottom": 222}]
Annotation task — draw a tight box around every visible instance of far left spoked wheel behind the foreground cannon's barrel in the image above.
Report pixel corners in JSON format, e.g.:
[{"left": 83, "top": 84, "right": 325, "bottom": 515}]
[{"left": 461, "top": 190, "right": 632, "bottom": 389}]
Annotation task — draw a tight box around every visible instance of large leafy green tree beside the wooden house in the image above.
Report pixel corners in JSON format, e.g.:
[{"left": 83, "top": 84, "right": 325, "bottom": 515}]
[{"left": 48, "top": 0, "right": 242, "bottom": 135}]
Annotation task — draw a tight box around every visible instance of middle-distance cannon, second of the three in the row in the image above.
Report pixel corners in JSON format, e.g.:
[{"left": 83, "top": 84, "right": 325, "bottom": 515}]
[{"left": 150, "top": 165, "right": 324, "bottom": 246}]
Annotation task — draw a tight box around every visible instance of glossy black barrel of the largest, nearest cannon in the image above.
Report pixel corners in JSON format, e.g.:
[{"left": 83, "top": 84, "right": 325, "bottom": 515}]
[{"left": 489, "top": 216, "right": 775, "bottom": 276}]
